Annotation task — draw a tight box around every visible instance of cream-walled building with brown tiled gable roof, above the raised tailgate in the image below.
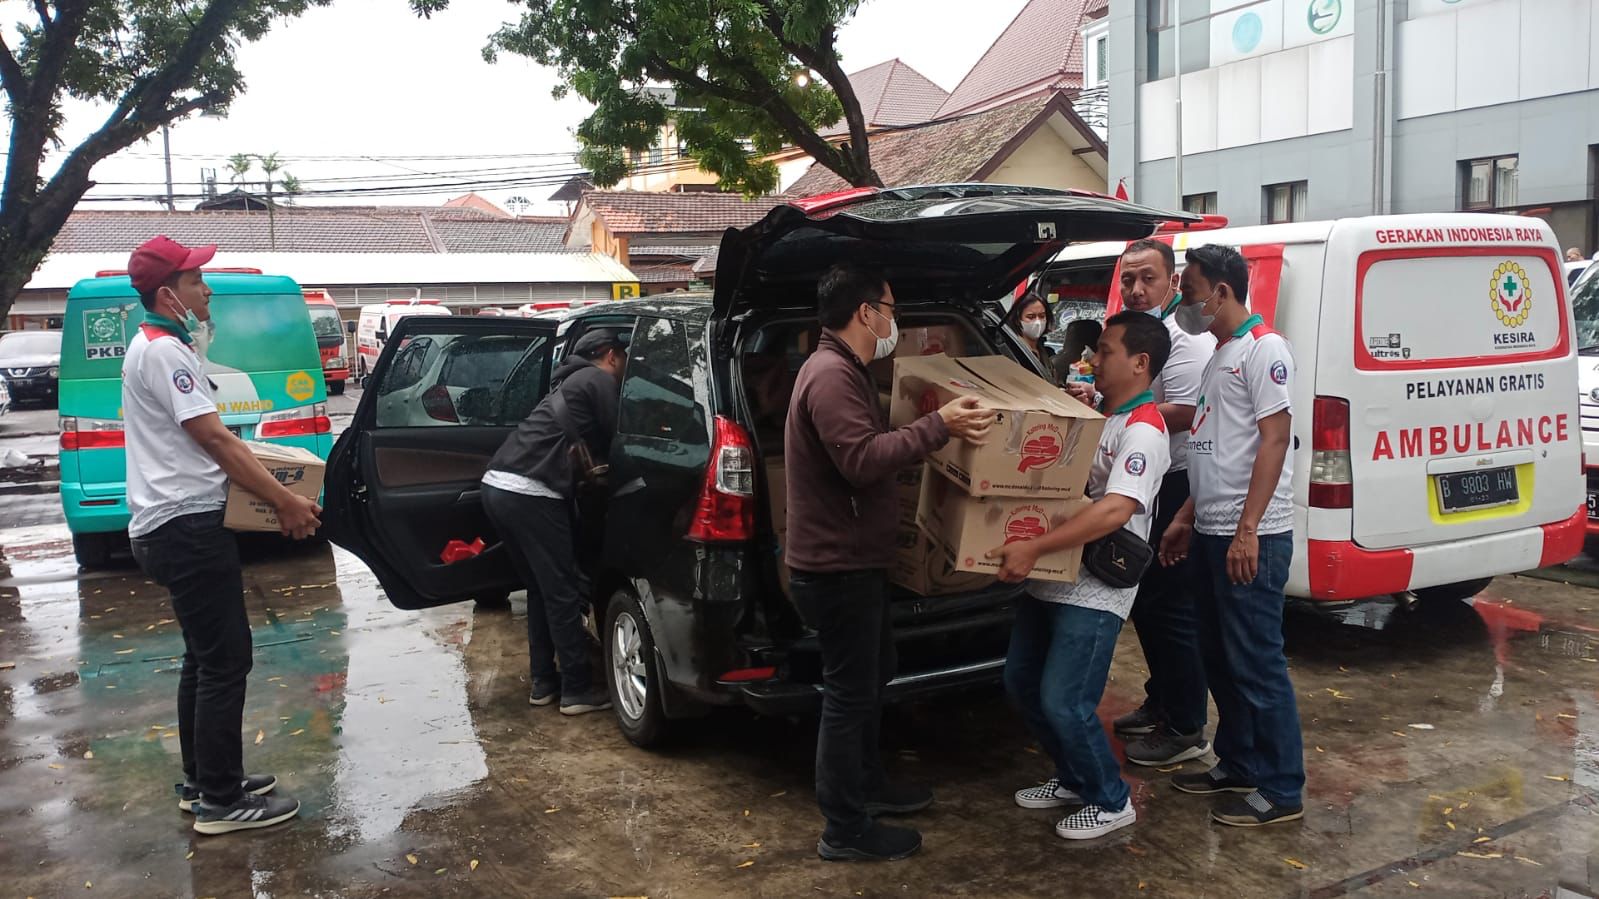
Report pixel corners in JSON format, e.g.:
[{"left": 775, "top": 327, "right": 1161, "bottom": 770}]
[{"left": 787, "top": 93, "right": 1107, "bottom": 197}]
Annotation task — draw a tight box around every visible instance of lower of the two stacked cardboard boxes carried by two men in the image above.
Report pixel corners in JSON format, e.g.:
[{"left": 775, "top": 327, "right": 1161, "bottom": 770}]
[{"left": 916, "top": 463, "right": 1094, "bottom": 581}]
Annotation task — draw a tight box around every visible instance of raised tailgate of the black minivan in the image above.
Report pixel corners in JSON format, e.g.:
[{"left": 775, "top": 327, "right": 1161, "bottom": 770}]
[{"left": 715, "top": 184, "right": 1199, "bottom": 318}]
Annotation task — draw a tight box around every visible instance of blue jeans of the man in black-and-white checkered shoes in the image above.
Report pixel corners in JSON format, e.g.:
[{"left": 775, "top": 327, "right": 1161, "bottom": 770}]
[{"left": 1004, "top": 597, "right": 1127, "bottom": 811}]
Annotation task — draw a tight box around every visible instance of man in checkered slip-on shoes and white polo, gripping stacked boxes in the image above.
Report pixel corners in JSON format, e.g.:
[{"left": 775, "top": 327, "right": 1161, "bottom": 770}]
[{"left": 988, "top": 312, "right": 1172, "bottom": 840}]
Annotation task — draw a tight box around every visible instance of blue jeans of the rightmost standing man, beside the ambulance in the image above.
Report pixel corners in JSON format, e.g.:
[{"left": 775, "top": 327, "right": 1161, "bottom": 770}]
[{"left": 1190, "top": 534, "right": 1305, "bottom": 806}]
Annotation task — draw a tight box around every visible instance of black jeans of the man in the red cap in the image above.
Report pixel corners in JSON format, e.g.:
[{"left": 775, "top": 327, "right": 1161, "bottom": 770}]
[{"left": 131, "top": 510, "right": 254, "bottom": 805}]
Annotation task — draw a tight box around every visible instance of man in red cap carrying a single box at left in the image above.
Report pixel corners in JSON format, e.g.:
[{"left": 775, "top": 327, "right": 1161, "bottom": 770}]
[{"left": 122, "top": 237, "right": 321, "bottom": 833}]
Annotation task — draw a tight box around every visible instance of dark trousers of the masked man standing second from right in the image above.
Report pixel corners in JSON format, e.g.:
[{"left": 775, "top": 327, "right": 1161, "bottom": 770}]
[{"left": 1132, "top": 472, "right": 1207, "bottom": 734}]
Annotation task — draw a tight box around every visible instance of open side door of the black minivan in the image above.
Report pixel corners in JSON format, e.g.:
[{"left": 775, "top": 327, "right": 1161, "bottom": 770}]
[{"left": 323, "top": 315, "right": 558, "bottom": 609}]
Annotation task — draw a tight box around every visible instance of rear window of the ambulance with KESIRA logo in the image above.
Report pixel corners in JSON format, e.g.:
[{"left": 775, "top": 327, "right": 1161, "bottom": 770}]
[{"left": 1356, "top": 248, "right": 1565, "bottom": 368}]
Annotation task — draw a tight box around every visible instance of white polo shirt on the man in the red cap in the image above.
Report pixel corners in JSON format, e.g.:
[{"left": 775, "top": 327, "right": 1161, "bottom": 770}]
[{"left": 122, "top": 323, "right": 227, "bottom": 537}]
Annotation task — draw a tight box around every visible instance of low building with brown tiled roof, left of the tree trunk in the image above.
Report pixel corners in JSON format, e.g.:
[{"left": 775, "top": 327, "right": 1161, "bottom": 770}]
[{"left": 566, "top": 190, "right": 787, "bottom": 293}]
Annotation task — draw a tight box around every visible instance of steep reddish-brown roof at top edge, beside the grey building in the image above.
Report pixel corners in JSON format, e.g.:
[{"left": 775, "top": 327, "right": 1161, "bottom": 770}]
[{"left": 939, "top": 0, "right": 1089, "bottom": 118}]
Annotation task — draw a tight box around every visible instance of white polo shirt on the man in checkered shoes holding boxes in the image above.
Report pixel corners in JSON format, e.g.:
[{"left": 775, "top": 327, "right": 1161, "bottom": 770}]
[{"left": 1027, "top": 390, "right": 1172, "bottom": 621}]
